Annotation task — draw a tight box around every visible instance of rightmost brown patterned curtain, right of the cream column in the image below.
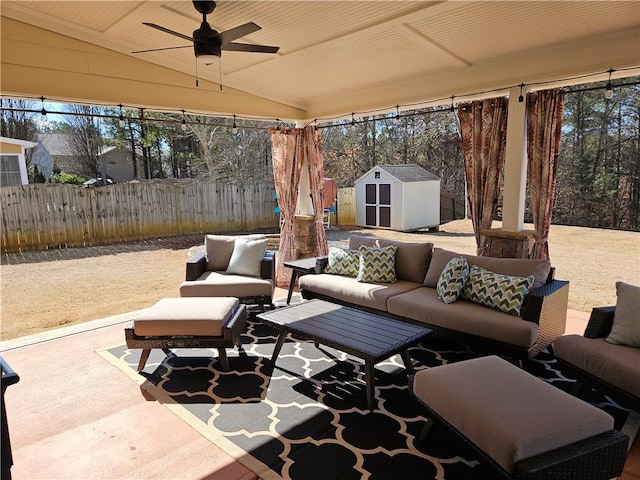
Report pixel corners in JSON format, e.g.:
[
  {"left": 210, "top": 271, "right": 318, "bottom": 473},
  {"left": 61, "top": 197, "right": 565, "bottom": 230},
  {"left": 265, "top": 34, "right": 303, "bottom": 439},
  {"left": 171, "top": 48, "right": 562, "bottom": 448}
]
[{"left": 527, "top": 89, "right": 564, "bottom": 259}]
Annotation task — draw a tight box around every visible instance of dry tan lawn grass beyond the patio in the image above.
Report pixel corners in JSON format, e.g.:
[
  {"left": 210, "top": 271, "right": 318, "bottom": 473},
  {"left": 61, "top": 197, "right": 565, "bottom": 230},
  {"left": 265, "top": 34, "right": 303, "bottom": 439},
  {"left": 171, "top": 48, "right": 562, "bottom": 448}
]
[{"left": 0, "top": 220, "right": 640, "bottom": 340}]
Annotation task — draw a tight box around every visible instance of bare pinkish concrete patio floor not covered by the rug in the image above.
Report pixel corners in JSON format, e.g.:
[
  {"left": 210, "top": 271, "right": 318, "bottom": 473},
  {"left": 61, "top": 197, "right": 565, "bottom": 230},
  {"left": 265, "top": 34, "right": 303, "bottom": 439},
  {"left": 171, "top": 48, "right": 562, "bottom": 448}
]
[{"left": 0, "top": 289, "right": 640, "bottom": 480}]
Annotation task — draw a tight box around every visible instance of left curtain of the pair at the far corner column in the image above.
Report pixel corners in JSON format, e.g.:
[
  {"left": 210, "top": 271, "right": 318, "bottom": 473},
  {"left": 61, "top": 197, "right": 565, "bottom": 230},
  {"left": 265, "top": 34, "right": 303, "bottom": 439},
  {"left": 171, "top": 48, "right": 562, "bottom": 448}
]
[{"left": 270, "top": 128, "right": 303, "bottom": 287}]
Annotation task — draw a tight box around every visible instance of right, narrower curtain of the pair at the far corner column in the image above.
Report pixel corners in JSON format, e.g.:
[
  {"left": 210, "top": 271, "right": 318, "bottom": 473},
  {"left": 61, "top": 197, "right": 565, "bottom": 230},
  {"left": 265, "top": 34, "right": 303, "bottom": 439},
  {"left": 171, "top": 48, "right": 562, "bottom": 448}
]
[{"left": 304, "top": 125, "right": 329, "bottom": 256}]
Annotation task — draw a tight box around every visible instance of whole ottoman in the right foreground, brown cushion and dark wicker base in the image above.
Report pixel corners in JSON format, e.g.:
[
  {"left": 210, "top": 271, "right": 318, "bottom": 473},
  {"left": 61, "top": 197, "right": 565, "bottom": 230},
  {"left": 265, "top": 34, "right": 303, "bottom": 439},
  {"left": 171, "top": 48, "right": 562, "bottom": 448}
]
[{"left": 412, "top": 356, "right": 628, "bottom": 480}]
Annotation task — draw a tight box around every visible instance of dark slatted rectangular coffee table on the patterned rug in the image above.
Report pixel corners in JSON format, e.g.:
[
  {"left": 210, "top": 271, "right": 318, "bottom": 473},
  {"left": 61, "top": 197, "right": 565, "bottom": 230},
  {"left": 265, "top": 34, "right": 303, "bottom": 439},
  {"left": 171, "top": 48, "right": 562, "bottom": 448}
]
[{"left": 258, "top": 300, "right": 431, "bottom": 410}]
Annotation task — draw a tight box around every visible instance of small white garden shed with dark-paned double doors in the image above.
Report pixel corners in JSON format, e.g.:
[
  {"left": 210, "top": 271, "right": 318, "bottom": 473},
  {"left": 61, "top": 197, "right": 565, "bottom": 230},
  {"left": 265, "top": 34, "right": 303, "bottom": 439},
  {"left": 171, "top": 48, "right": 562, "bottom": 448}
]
[{"left": 355, "top": 164, "right": 440, "bottom": 232}]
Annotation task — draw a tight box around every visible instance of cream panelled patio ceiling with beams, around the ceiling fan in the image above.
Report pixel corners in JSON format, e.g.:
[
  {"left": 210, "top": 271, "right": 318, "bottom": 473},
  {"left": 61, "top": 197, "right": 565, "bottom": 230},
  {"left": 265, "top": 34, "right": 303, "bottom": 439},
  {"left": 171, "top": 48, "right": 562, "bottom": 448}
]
[{"left": 0, "top": 0, "right": 640, "bottom": 120}]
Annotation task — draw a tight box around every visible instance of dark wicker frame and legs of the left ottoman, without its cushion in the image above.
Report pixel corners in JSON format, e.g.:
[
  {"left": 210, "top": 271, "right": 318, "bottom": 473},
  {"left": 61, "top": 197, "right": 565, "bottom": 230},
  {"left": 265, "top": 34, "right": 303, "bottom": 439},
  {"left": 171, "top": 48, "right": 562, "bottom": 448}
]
[{"left": 124, "top": 304, "right": 247, "bottom": 372}]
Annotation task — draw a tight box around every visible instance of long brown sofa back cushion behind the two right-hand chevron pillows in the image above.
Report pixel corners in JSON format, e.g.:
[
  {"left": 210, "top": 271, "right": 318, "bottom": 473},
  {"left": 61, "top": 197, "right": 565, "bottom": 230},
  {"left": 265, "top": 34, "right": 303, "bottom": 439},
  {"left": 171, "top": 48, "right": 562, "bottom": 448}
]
[{"left": 423, "top": 248, "right": 551, "bottom": 288}]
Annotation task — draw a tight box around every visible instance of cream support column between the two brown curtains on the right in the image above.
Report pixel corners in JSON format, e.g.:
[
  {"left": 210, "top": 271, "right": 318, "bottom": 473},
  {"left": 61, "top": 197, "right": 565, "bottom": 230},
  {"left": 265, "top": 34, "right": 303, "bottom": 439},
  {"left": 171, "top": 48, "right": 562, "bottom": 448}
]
[{"left": 502, "top": 87, "right": 527, "bottom": 232}]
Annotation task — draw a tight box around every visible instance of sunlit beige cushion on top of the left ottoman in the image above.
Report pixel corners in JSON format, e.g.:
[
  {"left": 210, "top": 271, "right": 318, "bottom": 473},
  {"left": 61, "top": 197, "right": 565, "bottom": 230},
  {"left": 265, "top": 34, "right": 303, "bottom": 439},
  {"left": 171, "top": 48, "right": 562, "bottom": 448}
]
[{"left": 133, "top": 297, "right": 239, "bottom": 337}]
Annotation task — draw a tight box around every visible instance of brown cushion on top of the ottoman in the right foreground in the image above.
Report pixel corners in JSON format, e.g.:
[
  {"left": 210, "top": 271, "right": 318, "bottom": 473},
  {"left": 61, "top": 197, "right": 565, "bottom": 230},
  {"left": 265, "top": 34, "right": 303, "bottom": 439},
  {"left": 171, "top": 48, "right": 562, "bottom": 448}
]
[{"left": 414, "top": 356, "right": 613, "bottom": 473}]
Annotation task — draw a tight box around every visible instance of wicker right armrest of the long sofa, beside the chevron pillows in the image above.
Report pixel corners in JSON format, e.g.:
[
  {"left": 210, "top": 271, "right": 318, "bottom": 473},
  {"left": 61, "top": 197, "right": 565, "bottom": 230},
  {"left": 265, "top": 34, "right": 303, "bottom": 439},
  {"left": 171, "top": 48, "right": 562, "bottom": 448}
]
[{"left": 522, "top": 280, "right": 569, "bottom": 358}]
